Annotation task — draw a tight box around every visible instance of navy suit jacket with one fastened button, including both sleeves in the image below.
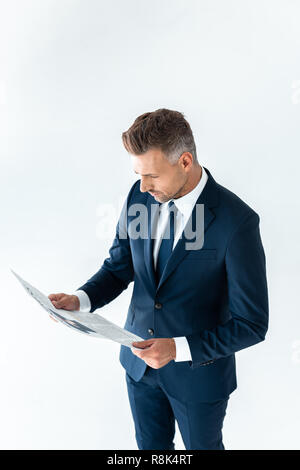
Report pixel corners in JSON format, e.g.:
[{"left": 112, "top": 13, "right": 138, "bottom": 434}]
[{"left": 78, "top": 168, "right": 268, "bottom": 401}]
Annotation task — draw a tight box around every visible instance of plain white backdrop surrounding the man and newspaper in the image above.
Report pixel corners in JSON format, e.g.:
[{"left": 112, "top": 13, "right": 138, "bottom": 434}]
[{"left": 0, "top": 0, "right": 300, "bottom": 449}]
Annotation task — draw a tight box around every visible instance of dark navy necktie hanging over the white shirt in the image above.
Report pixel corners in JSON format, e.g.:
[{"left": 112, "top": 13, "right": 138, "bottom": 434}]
[{"left": 155, "top": 201, "right": 177, "bottom": 285}]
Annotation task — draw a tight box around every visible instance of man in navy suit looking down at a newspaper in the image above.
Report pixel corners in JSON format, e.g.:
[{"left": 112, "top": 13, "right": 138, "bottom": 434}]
[{"left": 49, "top": 108, "right": 268, "bottom": 450}]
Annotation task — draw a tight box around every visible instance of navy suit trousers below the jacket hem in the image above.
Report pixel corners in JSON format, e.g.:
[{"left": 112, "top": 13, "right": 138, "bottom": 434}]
[{"left": 126, "top": 366, "right": 229, "bottom": 450}]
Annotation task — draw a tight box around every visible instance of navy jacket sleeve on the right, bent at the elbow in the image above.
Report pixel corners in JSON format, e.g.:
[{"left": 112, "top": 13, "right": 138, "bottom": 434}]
[{"left": 187, "top": 210, "right": 269, "bottom": 367}]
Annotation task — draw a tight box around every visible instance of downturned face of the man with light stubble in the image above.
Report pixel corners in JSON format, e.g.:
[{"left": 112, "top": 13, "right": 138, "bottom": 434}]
[{"left": 131, "top": 149, "right": 189, "bottom": 202}]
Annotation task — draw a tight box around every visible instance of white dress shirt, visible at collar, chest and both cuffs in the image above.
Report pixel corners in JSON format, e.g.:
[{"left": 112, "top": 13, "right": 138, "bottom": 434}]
[{"left": 73, "top": 167, "right": 208, "bottom": 361}]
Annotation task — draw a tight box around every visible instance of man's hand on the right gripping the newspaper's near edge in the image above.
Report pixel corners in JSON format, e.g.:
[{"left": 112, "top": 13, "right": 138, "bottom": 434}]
[{"left": 131, "top": 338, "right": 176, "bottom": 369}]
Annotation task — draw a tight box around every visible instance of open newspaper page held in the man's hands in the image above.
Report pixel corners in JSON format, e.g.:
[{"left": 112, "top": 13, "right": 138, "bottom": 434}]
[{"left": 11, "top": 269, "right": 143, "bottom": 349}]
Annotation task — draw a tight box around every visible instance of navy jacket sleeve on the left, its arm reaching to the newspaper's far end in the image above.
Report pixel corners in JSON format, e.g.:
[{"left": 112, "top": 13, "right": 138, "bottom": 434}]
[{"left": 78, "top": 180, "right": 139, "bottom": 312}]
